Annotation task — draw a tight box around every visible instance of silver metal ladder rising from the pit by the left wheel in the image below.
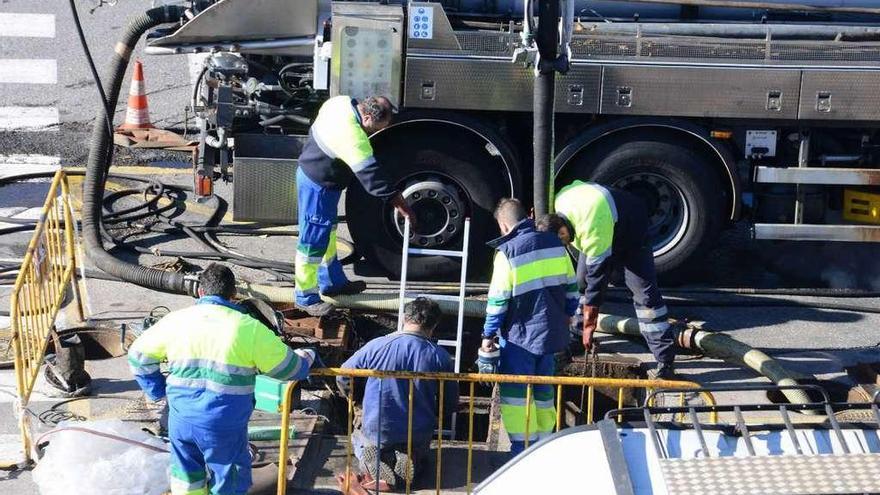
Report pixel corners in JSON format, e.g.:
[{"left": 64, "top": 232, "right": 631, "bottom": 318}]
[{"left": 397, "top": 218, "right": 471, "bottom": 436}]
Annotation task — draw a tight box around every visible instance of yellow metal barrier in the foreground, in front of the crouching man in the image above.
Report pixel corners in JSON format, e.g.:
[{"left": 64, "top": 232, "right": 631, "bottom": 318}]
[{"left": 277, "top": 368, "right": 717, "bottom": 495}]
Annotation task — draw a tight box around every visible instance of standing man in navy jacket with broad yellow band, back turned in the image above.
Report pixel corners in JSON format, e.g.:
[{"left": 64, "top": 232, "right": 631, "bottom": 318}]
[{"left": 479, "top": 199, "right": 578, "bottom": 455}]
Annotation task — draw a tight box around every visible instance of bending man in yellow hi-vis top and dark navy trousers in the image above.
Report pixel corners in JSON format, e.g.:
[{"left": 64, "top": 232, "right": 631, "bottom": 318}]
[{"left": 538, "top": 181, "right": 675, "bottom": 379}]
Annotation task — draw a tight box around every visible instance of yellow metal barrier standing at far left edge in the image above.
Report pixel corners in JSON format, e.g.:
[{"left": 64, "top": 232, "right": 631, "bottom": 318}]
[{"left": 10, "top": 170, "right": 82, "bottom": 461}]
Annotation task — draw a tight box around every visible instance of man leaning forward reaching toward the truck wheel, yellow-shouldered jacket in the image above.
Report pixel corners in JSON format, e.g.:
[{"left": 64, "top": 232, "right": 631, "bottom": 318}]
[{"left": 294, "top": 96, "right": 415, "bottom": 316}]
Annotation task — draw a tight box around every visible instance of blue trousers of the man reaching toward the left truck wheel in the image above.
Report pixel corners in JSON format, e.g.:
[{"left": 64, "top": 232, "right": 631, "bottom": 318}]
[{"left": 294, "top": 168, "right": 348, "bottom": 306}]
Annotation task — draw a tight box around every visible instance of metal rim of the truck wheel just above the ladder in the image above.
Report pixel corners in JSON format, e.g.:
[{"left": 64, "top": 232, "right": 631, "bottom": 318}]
[{"left": 391, "top": 174, "right": 469, "bottom": 248}]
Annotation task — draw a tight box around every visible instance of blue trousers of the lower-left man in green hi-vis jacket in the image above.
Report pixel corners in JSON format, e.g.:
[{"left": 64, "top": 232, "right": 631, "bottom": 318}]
[{"left": 168, "top": 413, "right": 251, "bottom": 495}]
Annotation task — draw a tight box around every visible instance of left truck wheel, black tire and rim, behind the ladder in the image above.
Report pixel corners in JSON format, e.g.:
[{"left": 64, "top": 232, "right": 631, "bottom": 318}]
[{"left": 345, "top": 130, "right": 511, "bottom": 280}]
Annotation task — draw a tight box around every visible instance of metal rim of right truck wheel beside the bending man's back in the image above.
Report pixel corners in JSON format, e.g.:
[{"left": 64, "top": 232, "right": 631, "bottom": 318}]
[{"left": 613, "top": 173, "right": 690, "bottom": 256}]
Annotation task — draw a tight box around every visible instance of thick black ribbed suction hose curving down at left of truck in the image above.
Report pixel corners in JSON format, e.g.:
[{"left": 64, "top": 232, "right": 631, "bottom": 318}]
[{"left": 82, "top": 5, "right": 196, "bottom": 294}]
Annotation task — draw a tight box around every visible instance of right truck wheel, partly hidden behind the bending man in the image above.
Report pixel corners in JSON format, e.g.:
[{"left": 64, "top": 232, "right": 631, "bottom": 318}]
[{"left": 558, "top": 140, "right": 724, "bottom": 282}]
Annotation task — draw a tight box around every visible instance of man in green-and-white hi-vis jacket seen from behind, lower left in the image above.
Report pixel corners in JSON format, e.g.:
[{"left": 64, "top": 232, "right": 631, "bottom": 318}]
[{"left": 128, "top": 263, "right": 315, "bottom": 495}]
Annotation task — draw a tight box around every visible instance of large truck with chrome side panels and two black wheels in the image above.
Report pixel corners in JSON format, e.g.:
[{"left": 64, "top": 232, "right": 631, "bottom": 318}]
[{"left": 146, "top": 0, "right": 880, "bottom": 276}]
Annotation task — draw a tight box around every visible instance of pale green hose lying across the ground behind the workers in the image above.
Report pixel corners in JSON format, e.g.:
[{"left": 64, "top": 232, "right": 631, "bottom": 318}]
[{"left": 238, "top": 283, "right": 813, "bottom": 404}]
